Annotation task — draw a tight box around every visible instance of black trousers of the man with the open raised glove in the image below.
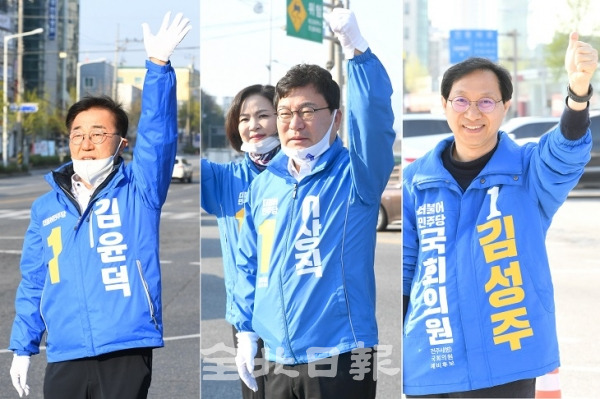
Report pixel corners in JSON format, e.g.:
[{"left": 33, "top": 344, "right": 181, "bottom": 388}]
[{"left": 44, "top": 348, "right": 152, "bottom": 399}]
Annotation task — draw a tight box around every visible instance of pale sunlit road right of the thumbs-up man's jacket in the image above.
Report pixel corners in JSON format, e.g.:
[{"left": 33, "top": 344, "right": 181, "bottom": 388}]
[{"left": 546, "top": 189, "right": 600, "bottom": 398}]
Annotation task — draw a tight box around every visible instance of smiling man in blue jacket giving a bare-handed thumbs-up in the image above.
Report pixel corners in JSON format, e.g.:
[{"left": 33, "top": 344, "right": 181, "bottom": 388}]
[{"left": 402, "top": 33, "right": 598, "bottom": 398}]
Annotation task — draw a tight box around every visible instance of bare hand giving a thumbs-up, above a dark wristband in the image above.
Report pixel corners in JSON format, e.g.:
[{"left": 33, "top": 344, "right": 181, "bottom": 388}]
[{"left": 565, "top": 32, "right": 598, "bottom": 96}]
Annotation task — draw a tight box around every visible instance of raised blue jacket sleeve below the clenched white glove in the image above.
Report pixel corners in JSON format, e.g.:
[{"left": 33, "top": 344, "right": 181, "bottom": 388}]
[{"left": 347, "top": 49, "right": 396, "bottom": 203}]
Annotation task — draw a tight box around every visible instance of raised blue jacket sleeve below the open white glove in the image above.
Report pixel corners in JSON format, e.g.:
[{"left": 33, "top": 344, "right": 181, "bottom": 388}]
[{"left": 132, "top": 61, "right": 177, "bottom": 209}]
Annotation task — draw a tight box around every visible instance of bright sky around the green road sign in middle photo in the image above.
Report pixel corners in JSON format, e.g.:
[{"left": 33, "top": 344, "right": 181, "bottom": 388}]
[{"left": 200, "top": 0, "right": 402, "bottom": 130}]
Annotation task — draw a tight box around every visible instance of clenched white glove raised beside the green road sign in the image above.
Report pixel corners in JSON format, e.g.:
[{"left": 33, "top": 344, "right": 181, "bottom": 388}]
[{"left": 323, "top": 7, "right": 369, "bottom": 60}]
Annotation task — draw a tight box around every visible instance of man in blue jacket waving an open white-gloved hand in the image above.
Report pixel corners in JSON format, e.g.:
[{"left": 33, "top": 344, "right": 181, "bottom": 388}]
[{"left": 9, "top": 13, "right": 191, "bottom": 399}]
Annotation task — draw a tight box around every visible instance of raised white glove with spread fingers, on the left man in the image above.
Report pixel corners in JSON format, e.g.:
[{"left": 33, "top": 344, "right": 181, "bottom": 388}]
[{"left": 142, "top": 11, "right": 192, "bottom": 62}]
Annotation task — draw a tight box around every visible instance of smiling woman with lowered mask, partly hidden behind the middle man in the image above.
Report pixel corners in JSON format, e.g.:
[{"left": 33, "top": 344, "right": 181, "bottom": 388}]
[{"left": 200, "top": 84, "right": 281, "bottom": 398}]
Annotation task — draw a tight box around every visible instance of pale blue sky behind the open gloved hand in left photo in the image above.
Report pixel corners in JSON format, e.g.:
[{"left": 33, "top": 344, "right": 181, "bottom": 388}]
[{"left": 79, "top": 0, "right": 200, "bottom": 68}]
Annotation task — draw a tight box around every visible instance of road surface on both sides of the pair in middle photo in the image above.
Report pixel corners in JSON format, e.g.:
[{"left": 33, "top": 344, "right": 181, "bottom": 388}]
[{"left": 201, "top": 213, "right": 402, "bottom": 399}]
